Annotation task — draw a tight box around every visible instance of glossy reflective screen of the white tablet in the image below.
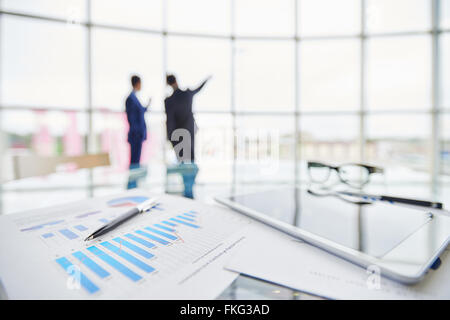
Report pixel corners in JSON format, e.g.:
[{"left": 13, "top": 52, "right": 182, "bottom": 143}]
[{"left": 230, "top": 188, "right": 432, "bottom": 257}]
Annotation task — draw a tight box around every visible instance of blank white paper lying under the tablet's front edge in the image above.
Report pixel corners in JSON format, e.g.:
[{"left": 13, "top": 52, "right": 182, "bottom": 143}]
[{"left": 225, "top": 224, "right": 450, "bottom": 299}]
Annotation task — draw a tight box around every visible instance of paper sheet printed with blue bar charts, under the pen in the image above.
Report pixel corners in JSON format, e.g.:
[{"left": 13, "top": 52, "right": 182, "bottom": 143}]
[{"left": 0, "top": 191, "right": 252, "bottom": 299}]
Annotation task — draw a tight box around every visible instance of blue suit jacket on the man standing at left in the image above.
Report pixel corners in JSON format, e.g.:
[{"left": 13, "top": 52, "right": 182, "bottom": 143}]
[{"left": 125, "top": 91, "right": 147, "bottom": 142}]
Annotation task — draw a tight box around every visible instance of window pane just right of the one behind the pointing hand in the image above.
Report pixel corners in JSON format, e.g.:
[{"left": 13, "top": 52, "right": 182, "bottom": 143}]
[{"left": 235, "top": 41, "right": 295, "bottom": 111}]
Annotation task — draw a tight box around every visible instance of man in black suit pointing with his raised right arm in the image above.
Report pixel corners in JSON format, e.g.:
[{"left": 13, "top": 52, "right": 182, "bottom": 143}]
[{"left": 164, "top": 75, "right": 209, "bottom": 162}]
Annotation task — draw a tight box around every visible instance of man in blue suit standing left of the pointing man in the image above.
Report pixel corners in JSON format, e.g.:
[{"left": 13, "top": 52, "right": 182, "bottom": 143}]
[{"left": 125, "top": 76, "right": 151, "bottom": 168}]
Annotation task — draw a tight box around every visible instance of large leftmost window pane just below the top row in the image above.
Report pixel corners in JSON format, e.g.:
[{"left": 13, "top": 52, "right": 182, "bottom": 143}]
[{"left": 0, "top": 16, "right": 87, "bottom": 109}]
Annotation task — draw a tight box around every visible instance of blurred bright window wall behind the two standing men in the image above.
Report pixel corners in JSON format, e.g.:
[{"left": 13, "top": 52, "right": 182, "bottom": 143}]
[{"left": 0, "top": 0, "right": 450, "bottom": 213}]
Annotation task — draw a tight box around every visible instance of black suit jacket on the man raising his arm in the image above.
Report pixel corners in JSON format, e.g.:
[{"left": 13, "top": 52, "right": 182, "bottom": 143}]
[{"left": 164, "top": 81, "right": 206, "bottom": 140}]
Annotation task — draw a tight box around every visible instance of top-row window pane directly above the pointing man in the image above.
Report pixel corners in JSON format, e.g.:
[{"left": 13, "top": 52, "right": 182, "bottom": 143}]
[{"left": 167, "top": 0, "right": 231, "bottom": 34}]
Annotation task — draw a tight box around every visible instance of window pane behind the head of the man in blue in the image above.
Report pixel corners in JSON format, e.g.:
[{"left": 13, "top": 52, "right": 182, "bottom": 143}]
[{"left": 92, "top": 29, "right": 165, "bottom": 110}]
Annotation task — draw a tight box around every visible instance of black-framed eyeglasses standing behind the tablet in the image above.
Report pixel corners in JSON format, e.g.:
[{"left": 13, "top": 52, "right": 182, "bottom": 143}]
[{"left": 308, "top": 161, "right": 384, "bottom": 188}]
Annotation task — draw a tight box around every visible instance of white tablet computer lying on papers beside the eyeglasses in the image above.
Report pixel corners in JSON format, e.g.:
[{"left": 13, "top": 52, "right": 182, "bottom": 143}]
[{"left": 216, "top": 188, "right": 450, "bottom": 284}]
